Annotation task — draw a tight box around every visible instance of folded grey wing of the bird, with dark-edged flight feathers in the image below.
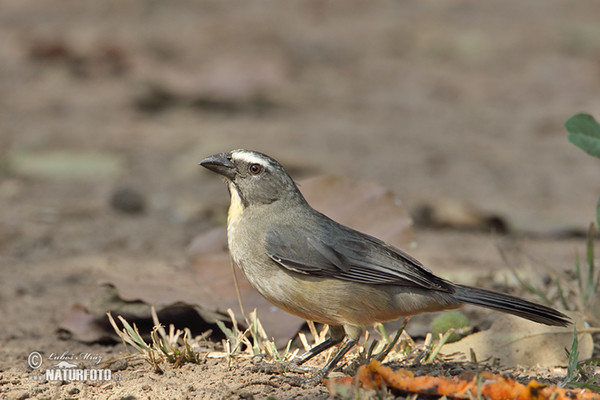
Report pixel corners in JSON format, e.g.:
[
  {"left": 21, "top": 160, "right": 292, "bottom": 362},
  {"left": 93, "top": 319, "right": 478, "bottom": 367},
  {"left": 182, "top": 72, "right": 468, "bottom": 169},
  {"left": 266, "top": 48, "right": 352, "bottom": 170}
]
[{"left": 265, "top": 224, "right": 453, "bottom": 291}]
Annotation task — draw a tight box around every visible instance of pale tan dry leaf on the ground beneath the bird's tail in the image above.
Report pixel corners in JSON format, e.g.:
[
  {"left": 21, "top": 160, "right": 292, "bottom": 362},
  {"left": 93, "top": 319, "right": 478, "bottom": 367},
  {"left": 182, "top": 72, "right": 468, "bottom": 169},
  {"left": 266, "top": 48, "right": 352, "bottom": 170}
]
[{"left": 441, "top": 315, "right": 594, "bottom": 367}]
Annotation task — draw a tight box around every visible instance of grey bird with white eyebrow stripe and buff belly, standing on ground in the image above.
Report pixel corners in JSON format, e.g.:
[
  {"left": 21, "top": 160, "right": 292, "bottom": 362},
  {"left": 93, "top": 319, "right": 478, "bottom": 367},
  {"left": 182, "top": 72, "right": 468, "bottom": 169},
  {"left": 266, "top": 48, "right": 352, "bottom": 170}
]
[{"left": 200, "top": 149, "right": 570, "bottom": 378}]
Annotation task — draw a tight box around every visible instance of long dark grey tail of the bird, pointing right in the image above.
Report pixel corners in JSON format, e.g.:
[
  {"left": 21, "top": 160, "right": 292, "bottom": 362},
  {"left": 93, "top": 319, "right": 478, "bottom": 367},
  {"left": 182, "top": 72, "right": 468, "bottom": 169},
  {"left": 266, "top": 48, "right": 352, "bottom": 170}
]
[{"left": 454, "top": 285, "right": 571, "bottom": 326}]
